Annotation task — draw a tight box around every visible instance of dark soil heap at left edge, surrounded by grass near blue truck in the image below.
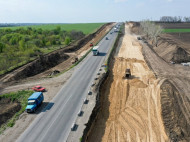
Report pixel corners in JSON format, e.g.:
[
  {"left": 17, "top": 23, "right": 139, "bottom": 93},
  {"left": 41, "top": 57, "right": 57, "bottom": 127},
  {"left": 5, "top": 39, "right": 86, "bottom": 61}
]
[{"left": 0, "top": 98, "right": 21, "bottom": 127}]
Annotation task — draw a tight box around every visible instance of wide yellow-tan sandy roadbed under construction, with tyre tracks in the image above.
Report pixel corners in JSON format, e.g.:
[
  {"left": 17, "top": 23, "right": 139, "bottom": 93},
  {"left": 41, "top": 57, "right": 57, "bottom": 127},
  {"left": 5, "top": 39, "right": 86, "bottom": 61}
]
[{"left": 87, "top": 24, "right": 168, "bottom": 142}]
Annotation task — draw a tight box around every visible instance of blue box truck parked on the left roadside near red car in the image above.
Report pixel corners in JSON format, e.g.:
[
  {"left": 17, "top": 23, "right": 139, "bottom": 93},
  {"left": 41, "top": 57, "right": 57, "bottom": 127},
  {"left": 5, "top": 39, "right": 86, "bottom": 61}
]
[{"left": 26, "top": 92, "right": 44, "bottom": 113}]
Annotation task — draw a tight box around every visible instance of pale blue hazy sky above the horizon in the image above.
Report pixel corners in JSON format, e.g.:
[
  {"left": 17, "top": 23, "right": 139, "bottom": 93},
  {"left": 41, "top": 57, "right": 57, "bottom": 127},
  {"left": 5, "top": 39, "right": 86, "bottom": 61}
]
[{"left": 0, "top": 0, "right": 190, "bottom": 23}]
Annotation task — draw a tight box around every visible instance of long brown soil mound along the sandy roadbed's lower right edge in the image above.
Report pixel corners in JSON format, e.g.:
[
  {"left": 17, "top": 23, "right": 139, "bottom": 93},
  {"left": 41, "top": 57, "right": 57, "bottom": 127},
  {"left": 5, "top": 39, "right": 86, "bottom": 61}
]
[{"left": 161, "top": 81, "right": 190, "bottom": 142}]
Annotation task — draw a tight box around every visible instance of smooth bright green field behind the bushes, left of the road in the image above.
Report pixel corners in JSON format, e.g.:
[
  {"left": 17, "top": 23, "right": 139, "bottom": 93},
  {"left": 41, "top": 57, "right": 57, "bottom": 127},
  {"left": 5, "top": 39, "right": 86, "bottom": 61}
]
[{"left": 0, "top": 23, "right": 105, "bottom": 34}]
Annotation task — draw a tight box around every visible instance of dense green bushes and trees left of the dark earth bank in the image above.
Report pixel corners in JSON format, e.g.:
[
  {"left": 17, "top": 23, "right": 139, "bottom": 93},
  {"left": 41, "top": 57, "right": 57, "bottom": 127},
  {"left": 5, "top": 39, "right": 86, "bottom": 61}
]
[{"left": 0, "top": 26, "right": 85, "bottom": 74}]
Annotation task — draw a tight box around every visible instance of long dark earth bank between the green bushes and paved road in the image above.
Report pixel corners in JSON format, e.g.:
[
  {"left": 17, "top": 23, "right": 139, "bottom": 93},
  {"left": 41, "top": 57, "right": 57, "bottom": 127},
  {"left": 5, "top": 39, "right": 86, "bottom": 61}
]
[{"left": 0, "top": 23, "right": 113, "bottom": 86}]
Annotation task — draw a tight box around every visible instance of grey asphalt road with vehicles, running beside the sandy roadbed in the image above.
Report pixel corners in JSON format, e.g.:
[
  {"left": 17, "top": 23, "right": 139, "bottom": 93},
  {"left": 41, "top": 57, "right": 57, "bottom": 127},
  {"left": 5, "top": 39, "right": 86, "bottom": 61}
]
[{"left": 16, "top": 23, "right": 117, "bottom": 142}]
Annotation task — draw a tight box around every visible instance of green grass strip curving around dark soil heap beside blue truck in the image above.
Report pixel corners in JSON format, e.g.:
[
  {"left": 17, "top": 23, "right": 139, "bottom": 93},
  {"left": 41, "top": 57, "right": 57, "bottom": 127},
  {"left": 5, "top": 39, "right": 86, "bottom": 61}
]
[{"left": 0, "top": 90, "right": 33, "bottom": 134}]
